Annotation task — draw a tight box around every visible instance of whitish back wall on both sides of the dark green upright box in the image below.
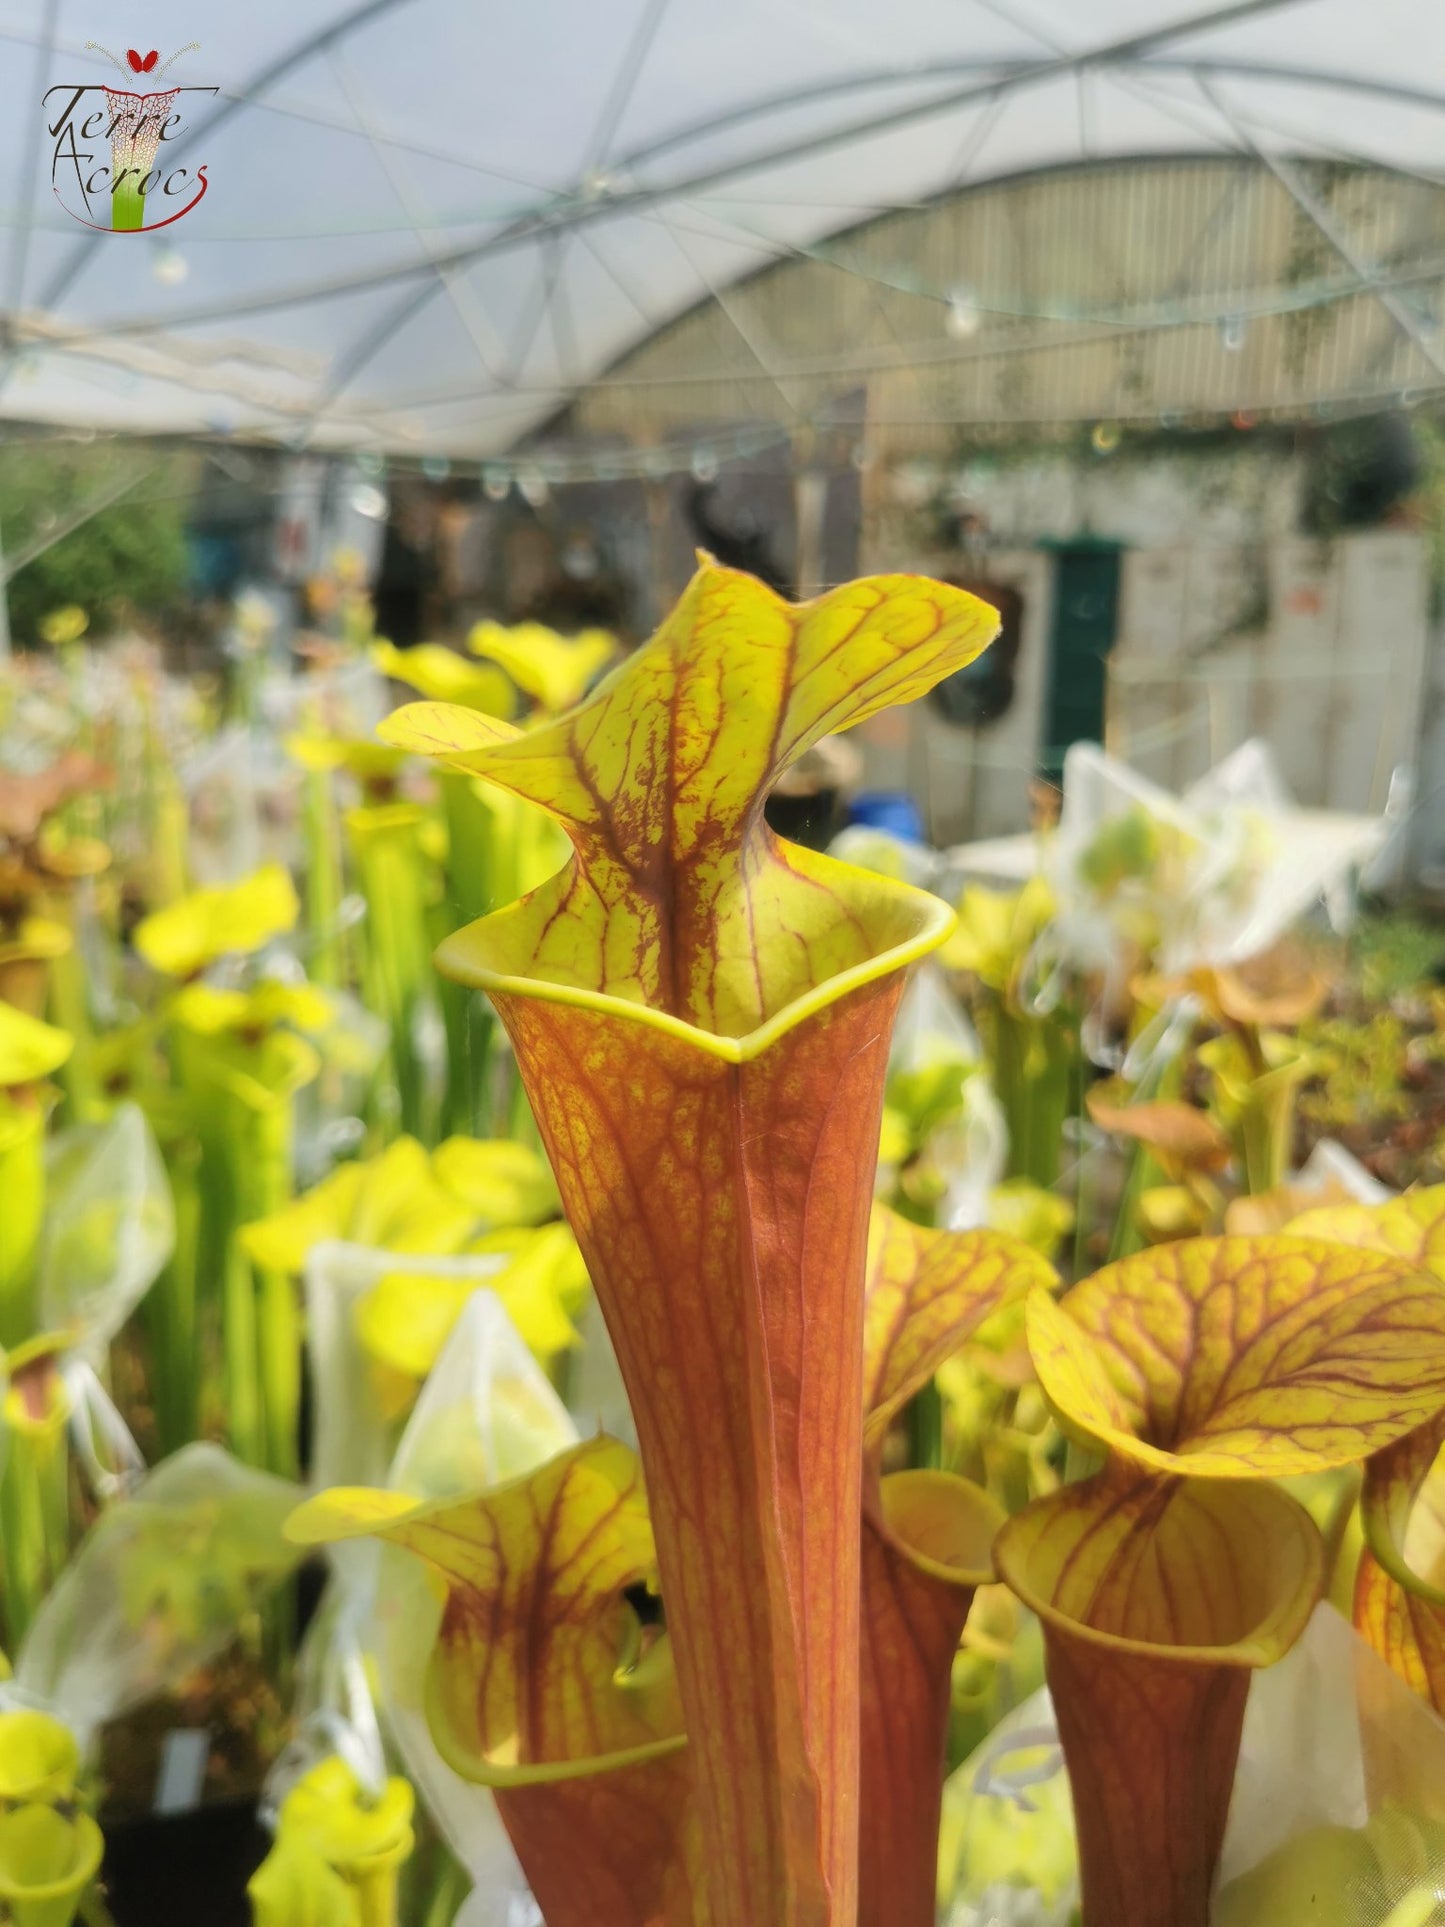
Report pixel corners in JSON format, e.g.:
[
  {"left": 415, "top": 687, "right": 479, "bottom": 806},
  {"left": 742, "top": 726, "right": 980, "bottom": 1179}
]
[{"left": 854, "top": 528, "right": 1445, "bottom": 844}]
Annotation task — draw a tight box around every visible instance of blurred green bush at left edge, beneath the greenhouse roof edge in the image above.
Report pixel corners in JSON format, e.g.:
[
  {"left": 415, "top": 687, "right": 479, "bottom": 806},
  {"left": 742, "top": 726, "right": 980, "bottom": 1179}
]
[{"left": 0, "top": 441, "right": 191, "bottom": 644}]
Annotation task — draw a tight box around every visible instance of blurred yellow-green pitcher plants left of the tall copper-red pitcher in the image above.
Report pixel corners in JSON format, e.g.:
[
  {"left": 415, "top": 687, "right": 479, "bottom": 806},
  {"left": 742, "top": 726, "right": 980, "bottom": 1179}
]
[{"left": 0, "top": 594, "right": 617, "bottom": 1923}]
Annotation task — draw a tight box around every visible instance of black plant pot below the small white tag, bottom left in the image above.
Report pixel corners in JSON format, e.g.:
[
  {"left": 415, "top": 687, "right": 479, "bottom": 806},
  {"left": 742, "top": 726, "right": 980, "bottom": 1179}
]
[{"left": 102, "top": 1802, "right": 270, "bottom": 1927}]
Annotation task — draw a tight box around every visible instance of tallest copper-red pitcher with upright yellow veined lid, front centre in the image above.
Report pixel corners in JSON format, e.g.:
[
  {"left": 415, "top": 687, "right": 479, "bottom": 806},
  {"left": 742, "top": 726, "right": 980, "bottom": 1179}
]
[{"left": 296, "top": 563, "right": 998, "bottom": 1927}]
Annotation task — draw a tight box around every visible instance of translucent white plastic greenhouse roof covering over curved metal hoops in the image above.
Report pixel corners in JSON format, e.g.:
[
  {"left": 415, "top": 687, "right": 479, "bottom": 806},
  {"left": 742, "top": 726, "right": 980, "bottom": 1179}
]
[{"left": 0, "top": 0, "right": 1445, "bottom": 457}]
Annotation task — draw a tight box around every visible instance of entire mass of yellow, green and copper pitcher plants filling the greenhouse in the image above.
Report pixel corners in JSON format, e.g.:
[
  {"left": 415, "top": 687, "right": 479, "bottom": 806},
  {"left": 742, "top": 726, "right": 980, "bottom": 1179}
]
[{"left": 0, "top": 563, "right": 1445, "bottom": 1927}]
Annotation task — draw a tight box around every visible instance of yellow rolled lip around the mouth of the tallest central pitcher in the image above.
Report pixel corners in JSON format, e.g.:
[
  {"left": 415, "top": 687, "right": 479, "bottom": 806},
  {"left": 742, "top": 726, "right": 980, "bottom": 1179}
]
[{"left": 435, "top": 844, "right": 958, "bottom": 1064}]
